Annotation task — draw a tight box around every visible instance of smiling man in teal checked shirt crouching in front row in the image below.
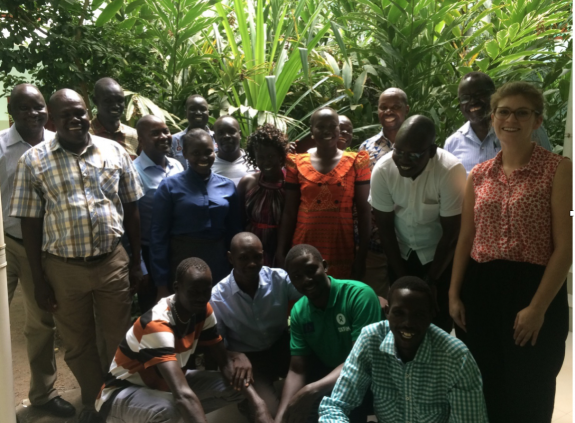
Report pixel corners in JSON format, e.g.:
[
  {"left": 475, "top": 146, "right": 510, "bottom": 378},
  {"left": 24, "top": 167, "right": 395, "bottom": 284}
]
[{"left": 319, "top": 276, "right": 488, "bottom": 423}]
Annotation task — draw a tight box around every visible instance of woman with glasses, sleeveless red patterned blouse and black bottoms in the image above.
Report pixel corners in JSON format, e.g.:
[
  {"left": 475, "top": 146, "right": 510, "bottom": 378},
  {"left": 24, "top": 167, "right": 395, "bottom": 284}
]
[{"left": 449, "top": 82, "right": 572, "bottom": 423}]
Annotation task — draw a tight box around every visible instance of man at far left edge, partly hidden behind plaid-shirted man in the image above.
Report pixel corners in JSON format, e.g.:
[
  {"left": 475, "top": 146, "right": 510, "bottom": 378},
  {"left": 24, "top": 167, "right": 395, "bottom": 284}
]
[{"left": 0, "top": 84, "right": 76, "bottom": 417}]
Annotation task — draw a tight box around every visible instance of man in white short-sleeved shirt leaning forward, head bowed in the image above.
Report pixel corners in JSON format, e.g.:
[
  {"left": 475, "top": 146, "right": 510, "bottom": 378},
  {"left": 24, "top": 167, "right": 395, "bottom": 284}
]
[{"left": 369, "top": 115, "right": 466, "bottom": 332}]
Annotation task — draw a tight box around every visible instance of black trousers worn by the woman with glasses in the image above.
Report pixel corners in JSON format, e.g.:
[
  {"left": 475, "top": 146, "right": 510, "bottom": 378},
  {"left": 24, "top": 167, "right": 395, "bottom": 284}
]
[{"left": 461, "top": 260, "right": 569, "bottom": 423}]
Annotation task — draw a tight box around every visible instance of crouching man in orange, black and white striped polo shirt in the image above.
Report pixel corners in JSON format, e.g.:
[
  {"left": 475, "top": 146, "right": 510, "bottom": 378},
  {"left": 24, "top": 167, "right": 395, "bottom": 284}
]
[{"left": 96, "top": 257, "right": 273, "bottom": 423}]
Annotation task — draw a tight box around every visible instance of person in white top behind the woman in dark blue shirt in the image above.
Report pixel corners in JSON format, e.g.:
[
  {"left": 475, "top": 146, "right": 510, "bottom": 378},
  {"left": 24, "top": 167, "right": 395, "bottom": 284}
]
[{"left": 212, "top": 116, "right": 255, "bottom": 186}]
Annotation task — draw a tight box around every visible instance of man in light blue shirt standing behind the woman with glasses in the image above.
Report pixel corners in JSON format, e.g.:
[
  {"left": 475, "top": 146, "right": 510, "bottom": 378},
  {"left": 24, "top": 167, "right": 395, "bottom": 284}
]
[{"left": 443, "top": 72, "right": 552, "bottom": 174}]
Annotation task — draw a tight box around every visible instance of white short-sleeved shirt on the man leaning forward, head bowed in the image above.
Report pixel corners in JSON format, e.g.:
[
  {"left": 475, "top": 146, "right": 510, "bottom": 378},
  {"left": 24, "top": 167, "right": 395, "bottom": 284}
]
[{"left": 368, "top": 148, "right": 466, "bottom": 264}]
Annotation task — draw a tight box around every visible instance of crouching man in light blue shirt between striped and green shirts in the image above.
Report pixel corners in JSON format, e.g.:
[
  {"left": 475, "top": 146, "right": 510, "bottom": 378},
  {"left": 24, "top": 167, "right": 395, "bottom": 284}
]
[{"left": 210, "top": 232, "right": 301, "bottom": 416}]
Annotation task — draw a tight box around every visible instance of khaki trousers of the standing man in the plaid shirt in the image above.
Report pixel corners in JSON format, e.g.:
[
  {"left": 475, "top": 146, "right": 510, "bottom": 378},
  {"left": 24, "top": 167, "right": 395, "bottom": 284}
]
[{"left": 44, "top": 245, "right": 132, "bottom": 409}]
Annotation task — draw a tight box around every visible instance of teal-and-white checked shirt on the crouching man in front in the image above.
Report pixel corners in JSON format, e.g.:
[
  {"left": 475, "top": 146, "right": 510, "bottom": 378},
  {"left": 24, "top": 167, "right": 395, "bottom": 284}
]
[{"left": 319, "top": 321, "right": 488, "bottom": 423}]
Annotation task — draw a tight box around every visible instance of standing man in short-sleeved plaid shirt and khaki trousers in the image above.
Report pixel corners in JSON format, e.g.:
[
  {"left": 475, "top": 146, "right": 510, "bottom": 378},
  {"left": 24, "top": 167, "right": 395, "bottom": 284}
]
[{"left": 10, "top": 89, "right": 143, "bottom": 423}]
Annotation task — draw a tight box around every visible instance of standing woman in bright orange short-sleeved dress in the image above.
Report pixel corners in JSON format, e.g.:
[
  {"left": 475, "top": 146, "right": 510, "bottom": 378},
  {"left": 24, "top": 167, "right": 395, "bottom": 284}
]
[{"left": 276, "top": 107, "right": 371, "bottom": 280}]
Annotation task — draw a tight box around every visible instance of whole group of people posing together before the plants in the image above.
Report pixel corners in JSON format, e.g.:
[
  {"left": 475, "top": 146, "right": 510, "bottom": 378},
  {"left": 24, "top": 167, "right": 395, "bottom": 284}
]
[{"left": 0, "top": 72, "right": 572, "bottom": 423}]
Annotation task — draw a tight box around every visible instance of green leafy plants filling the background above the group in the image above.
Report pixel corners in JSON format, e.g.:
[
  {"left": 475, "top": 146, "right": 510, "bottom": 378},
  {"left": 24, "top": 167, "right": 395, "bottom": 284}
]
[{"left": 0, "top": 0, "right": 572, "bottom": 149}]
